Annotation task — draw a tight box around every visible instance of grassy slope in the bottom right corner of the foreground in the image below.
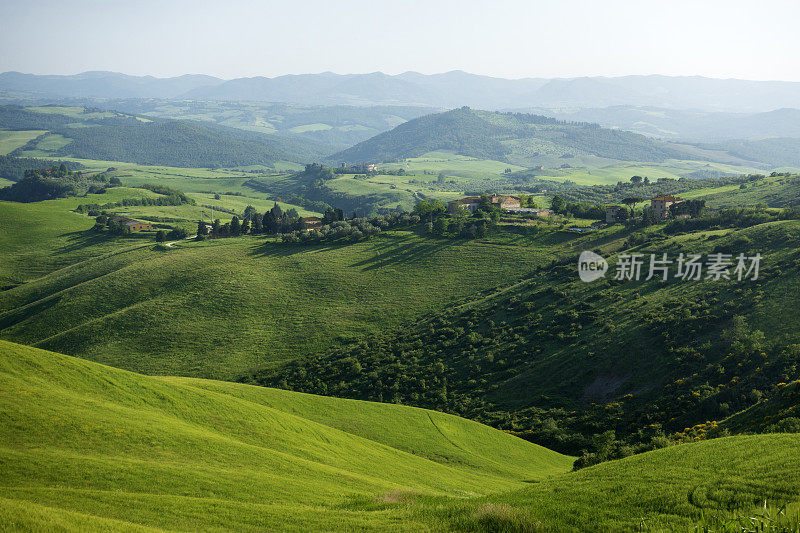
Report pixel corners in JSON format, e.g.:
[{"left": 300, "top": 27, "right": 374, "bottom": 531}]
[{"left": 413, "top": 434, "right": 800, "bottom": 531}]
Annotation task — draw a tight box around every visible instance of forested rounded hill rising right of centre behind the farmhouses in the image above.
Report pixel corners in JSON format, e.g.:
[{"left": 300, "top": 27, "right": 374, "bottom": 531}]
[{"left": 328, "top": 107, "right": 764, "bottom": 167}]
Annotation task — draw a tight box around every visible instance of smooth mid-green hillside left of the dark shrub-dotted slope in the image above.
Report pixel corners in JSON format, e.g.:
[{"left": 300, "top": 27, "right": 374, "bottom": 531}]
[{"left": 0, "top": 225, "right": 564, "bottom": 377}]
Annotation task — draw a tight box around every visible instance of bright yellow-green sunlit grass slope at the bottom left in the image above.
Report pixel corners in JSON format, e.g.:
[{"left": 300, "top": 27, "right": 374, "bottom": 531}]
[{"left": 0, "top": 341, "right": 572, "bottom": 530}]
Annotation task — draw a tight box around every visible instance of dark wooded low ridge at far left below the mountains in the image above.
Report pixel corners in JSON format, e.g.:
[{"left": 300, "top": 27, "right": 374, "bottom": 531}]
[{"left": 0, "top": 106, "right": 328, "bottom": 167}]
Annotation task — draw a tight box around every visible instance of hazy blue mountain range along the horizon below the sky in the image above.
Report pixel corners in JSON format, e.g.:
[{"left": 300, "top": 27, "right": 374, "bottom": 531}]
[{"left": 0, "top": 71, "right": 800, "bottom": 113}]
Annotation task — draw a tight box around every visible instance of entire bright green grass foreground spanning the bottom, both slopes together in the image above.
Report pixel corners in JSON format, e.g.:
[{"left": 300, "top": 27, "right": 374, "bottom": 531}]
[{"left": 0, "top": 341, "right": 800, "bottom": 531}]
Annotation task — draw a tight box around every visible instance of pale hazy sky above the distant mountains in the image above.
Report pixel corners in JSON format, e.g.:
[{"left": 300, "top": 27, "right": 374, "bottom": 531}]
[{"left": 0, "top": 0, "right": 800, "bottom": 81}]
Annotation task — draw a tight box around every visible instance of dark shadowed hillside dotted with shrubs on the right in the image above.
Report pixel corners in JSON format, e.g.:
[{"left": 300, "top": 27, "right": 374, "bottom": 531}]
[{"left": 253, "top": 220, "right": 800, "bottom": 454}]
